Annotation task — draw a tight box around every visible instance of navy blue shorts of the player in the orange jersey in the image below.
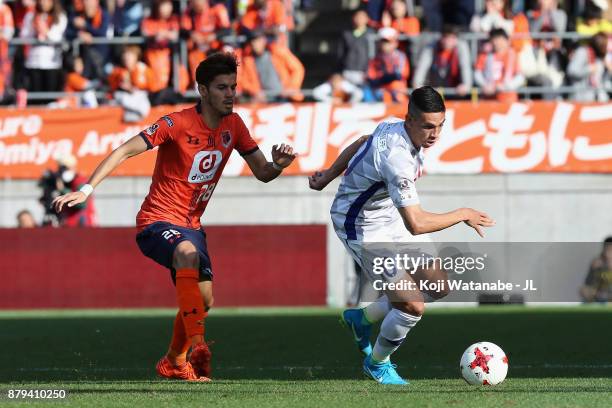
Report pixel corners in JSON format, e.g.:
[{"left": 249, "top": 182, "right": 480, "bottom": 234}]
[{"left": 136, "top": 221, "right": 213, "bottom": 284}]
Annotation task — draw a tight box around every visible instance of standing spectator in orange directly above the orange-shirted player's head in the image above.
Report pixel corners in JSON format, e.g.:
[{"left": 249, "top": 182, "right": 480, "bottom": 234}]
[{"left": 181, "top": 0, "right": 231, "bottom": 82}]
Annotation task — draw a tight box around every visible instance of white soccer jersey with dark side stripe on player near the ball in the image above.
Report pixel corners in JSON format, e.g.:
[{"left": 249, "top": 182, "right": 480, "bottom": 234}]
[{"left": 331, "top": 119, "right": 424, "bottom": 242}]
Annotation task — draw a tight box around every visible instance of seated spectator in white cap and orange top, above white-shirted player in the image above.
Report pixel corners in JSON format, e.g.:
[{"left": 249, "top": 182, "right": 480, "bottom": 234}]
[{"left": 364, "top": 27, "right": 410, "bottom": 103}]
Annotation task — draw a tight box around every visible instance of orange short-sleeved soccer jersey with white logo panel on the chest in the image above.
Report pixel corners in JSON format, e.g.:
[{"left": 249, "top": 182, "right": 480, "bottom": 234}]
[{"left": 136, "top": 104, "right": 258, "bottom": 231}]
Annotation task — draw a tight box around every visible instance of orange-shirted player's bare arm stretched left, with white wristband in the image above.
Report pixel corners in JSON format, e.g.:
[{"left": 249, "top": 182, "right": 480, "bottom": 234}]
[{"left": 52, "top": 135, "right": 147, "bottom": 212}]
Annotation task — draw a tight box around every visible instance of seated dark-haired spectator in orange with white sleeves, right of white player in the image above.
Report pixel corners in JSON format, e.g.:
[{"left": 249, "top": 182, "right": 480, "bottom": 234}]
[{"left": 474, "top": 28, "right": 525, "bottom": 102}]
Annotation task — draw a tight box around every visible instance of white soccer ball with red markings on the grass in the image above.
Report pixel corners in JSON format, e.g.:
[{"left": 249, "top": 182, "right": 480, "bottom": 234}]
[{"left": 459, "top": 341, "right": 508, "bottom": 385}]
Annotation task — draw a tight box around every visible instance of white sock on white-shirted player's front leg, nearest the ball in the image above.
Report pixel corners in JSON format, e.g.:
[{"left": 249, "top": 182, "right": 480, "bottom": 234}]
[{"left": 372, "top": 309, "right": 421, "bottom": 362}]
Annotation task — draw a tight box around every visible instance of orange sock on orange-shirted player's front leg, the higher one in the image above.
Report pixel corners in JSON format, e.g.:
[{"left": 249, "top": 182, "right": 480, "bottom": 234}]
[{"left": 176, "top": 268, "right": 204, "bottom": 343}]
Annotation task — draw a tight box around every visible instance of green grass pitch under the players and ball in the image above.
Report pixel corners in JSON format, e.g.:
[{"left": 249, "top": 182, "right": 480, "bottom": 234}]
[{"left": 0, "top": 306, "right": 612, "bottom": 408}]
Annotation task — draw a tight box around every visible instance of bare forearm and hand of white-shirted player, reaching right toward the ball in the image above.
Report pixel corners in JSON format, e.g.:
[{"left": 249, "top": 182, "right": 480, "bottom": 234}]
[{"left": 398, "top": 204, "right": 495, "bottom": 238}]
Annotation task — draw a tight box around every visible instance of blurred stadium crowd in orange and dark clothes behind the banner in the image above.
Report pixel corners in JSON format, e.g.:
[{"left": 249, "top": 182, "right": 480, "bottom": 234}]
[{"left": 0, "top": 0, "right": 612, "bottom": 107}]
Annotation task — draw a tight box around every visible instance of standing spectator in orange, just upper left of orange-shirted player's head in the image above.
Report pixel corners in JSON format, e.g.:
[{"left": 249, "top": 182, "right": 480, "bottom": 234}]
[{"left": 142, "top": 0, "right": 179, "bottom": 92}]
